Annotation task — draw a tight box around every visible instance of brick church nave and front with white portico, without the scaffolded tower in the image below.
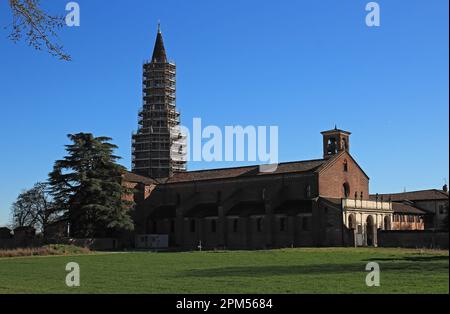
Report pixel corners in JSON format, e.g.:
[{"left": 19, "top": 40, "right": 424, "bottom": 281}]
[{"left": 124, "top": 129, "right": 412, "bottom": 249}]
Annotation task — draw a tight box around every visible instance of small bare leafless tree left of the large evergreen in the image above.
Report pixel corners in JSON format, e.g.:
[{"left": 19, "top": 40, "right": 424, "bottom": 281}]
[{"left": 11, "top": 182, "right": 57, "bottom": 235}]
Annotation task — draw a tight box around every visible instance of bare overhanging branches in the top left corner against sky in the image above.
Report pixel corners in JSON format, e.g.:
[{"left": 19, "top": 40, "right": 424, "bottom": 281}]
[{"left": 9, "top": 0, "right": 71, "bottom": 61}]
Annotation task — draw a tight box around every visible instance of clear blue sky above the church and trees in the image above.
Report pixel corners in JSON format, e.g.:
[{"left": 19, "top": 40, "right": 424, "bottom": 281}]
[{"left": 0, "top": 0, "right": 449, "bottom": 225}]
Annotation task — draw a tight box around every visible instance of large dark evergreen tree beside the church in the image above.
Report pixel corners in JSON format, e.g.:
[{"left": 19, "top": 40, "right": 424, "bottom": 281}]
[{"left": 49, "top": 133, "right": 134, "bottom": 237}]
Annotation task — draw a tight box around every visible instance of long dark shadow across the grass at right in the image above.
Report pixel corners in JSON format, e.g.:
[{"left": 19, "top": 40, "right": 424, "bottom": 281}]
[{"left": 178, "top": 260, "right": 448, "bottom": 278}]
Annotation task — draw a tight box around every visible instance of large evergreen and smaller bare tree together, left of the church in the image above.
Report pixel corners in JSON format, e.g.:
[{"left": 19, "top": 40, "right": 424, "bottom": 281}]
[{"left": 11, "top": 133, "right": 134, "bottom": 238}]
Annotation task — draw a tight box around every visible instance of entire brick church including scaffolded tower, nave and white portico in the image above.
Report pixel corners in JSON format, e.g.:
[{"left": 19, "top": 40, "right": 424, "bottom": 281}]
[{"left": 124, "top": 30, "right": 434, "bottom": 249}]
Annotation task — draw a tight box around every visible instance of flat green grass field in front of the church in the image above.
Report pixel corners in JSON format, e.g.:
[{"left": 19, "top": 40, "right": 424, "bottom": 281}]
[{"left": 0, "top": 248, "right": 449, "bottom": 294}]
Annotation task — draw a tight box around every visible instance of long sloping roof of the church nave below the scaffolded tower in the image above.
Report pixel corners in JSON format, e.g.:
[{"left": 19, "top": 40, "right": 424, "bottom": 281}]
[{"left": 165, "top": 159, "right": 328, "bottom": 183}]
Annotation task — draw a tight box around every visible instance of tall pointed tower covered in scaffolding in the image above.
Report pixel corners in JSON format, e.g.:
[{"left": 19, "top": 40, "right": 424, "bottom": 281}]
[{"left": 132, "top": 25, "right": 186, "bottom": 178}]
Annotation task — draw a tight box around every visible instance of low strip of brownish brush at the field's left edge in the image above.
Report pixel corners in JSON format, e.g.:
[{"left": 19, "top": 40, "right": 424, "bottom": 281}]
[{"left": 0, "top": 244, "right": 91, "bottom": 257}]
